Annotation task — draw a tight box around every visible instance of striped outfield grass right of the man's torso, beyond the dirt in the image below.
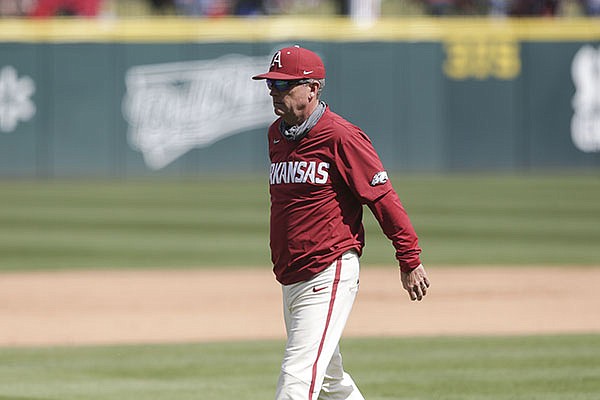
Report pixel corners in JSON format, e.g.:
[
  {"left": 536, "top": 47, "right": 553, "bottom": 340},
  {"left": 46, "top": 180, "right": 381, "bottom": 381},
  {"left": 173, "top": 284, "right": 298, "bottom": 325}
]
[{"left": 365, "top": 176, "right": 600, "bottom": 265}]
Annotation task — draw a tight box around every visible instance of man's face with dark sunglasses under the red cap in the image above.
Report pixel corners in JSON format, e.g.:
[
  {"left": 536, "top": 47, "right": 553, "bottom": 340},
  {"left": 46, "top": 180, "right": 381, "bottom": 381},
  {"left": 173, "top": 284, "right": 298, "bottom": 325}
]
[{"left": 267, "top": 79, "right": 314, "bottom": 125}]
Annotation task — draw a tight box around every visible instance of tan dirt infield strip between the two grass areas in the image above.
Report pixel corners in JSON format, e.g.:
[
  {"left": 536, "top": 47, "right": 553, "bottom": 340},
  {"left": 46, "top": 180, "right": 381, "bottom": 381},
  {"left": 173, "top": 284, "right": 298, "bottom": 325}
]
[{"left": 0, "top": 267, "right": 600, "bottom": 346}]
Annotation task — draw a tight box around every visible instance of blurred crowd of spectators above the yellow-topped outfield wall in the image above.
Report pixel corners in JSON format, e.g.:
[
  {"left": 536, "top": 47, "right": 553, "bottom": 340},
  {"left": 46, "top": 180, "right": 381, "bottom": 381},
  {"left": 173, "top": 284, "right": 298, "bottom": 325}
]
[{"left": 0, "top": 0, "right": 600, "bottom": 18}]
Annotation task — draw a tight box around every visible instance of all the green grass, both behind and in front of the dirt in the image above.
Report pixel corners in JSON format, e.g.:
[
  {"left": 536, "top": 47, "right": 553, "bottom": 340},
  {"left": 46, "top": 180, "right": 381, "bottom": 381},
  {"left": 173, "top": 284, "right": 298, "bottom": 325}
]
[{"left": 0, "top": 175, "right": 600, "bottom": 400}]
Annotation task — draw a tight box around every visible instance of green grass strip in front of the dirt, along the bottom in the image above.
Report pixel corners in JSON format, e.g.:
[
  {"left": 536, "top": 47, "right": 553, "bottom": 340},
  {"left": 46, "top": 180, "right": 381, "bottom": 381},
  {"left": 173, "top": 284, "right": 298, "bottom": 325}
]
[{"left": 0, "top": 335, "right": 600, "bottom": 400}]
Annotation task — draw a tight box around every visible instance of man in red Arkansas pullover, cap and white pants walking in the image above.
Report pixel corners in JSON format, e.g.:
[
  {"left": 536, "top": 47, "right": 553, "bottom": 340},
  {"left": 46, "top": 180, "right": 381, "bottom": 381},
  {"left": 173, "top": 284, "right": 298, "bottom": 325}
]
[{"left": 252, "top": 46, "right": 429, "bottom": 400}]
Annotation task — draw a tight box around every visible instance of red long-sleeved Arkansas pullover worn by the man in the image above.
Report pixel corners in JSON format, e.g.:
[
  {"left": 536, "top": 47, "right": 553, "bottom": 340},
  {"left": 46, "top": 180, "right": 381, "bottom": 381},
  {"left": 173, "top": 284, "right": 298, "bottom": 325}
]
[{"left": 268, "top": 108, "right": 421, "bottom": 285}]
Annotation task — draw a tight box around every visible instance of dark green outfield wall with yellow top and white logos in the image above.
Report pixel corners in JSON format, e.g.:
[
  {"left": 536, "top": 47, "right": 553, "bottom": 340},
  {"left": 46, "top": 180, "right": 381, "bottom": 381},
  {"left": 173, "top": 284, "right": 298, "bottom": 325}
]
[{"left": 0, "top": 18, "right": 600, "bottom": 178}]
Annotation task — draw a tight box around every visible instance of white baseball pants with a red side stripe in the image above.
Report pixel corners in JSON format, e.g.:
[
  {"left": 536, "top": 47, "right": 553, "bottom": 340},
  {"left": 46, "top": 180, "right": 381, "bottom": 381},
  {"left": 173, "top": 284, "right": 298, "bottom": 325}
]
[{"left": 275, "top": 251, "right": 364, "bottom": 400}]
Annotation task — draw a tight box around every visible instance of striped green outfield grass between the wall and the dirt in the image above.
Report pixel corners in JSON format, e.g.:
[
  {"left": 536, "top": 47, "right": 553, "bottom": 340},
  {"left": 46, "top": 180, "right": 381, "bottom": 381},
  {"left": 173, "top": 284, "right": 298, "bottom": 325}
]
[{"left": 0, "top": 174, "right": 600, "bottom": 270}]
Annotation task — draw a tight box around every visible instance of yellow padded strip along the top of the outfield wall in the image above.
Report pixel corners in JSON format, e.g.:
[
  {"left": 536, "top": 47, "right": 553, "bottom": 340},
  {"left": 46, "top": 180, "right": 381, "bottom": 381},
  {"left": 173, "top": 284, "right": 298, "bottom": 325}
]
[{"left": 0, "top": 17, "right": 600, "bottom": 42}]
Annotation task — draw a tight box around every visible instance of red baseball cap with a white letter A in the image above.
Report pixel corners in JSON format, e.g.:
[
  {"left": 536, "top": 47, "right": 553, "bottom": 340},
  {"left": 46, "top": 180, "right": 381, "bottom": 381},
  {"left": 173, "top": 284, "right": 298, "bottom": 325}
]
[{"left": 252, "top": 46, "right": 325, "bottom": 80}]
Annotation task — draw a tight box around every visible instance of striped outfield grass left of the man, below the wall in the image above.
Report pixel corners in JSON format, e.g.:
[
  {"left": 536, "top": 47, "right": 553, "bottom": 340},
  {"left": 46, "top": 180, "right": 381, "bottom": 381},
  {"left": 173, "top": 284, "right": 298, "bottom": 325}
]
[{"left": 0, "top": 179, "right": 269, "bottom": 269}]
